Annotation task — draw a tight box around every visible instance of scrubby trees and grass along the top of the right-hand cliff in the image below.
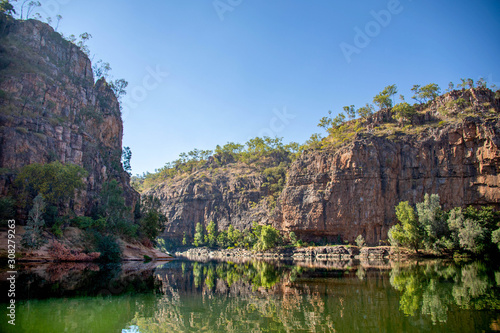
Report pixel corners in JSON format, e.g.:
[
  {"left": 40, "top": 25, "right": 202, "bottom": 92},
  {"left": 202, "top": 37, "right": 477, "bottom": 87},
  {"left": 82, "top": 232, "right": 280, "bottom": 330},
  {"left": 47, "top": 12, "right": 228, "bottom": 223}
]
[{"left": 310, "top": 79, "right": 500, "bottom": 151}]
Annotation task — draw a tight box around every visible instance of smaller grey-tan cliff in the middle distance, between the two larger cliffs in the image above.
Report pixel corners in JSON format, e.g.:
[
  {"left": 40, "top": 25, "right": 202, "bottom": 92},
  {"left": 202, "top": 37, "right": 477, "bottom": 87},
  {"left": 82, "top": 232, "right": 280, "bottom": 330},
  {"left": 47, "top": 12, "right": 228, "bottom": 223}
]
[{"left": 145, "top": 163, "right": 270, "bottom": 240}]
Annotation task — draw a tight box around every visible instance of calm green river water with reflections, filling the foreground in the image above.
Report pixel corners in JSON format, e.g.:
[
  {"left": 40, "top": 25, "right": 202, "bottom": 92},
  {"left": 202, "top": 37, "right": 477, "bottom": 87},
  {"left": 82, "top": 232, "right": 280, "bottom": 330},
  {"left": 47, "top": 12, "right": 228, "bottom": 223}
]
[{"left": 0, "top": 261, "right": 500, "bottom": 333}]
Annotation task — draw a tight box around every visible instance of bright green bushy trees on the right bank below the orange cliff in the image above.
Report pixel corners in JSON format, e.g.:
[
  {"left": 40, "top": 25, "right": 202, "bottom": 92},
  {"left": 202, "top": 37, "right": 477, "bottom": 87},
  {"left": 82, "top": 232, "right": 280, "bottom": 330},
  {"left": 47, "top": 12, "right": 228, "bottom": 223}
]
[{"left": 389, "top": 194, "right": 500, "bottom": 256}]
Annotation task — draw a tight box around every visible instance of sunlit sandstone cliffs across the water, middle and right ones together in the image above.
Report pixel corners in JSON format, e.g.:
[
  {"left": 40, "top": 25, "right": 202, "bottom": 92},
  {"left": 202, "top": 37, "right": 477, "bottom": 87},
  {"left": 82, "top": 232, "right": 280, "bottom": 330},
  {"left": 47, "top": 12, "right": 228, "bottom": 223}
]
[{"left": 147, "top": 88, "right": 500, "bottom": 244}]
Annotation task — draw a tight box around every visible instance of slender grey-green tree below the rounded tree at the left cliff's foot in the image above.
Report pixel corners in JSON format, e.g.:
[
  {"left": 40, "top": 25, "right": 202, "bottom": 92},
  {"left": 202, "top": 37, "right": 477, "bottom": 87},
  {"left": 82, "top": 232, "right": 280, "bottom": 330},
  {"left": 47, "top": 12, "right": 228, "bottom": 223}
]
[{"left": 21, "top": 194, "right": 45, "bottom": 250}]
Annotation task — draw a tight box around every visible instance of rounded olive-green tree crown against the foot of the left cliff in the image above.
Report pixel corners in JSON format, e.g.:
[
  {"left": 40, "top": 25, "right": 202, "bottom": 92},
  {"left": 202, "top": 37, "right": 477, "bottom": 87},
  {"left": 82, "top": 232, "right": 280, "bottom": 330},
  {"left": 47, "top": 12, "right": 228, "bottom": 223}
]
[{"left": 15, "top": 161, "right": 87, "bottom": 206}]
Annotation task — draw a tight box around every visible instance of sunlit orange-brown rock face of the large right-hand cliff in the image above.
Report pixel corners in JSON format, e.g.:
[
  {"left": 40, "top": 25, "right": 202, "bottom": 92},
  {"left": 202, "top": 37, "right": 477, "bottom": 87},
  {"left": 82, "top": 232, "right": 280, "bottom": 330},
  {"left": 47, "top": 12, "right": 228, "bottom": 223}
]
[{"left": 275, "top": 91, "right": 500, "bottom": 244}]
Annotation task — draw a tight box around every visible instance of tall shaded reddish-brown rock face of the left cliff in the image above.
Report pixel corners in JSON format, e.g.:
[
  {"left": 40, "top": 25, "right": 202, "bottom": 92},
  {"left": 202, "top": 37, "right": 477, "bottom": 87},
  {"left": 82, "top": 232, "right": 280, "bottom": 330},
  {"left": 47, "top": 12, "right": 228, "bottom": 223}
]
[{"left": 0, "top": 16, "right": 139, "bottom": 214}]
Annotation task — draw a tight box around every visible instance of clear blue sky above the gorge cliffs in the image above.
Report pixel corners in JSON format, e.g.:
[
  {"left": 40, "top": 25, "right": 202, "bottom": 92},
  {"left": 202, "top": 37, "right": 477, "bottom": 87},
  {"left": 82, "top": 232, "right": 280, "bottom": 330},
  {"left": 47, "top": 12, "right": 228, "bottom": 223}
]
[{"left": 14, "top": 0, "right": 500, "bottom": 174}]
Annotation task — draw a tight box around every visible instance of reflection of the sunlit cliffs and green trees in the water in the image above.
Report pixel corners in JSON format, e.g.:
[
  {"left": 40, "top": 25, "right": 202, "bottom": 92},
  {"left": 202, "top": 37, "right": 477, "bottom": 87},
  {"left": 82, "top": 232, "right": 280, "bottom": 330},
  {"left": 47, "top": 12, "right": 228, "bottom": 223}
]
[{"left": 128, "top": 261, "right": 500, "bottom": 332}]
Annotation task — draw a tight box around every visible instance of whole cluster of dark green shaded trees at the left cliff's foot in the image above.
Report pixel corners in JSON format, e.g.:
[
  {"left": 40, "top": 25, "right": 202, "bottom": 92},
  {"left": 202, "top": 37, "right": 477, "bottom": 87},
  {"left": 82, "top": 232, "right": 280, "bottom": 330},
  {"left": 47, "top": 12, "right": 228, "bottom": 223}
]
[{"left": 10, "top": 161, "right": 166, "bottom": 261}]
